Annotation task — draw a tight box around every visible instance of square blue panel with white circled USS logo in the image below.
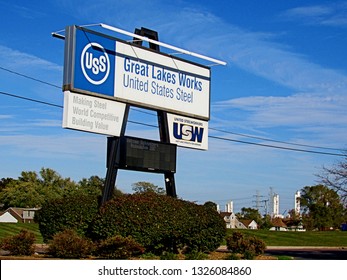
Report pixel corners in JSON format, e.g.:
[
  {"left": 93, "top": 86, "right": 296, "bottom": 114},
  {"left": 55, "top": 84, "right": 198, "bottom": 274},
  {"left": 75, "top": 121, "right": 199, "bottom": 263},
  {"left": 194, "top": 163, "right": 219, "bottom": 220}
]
[{"left": 73, "top": 29, "right": 116, "bottom": 96}]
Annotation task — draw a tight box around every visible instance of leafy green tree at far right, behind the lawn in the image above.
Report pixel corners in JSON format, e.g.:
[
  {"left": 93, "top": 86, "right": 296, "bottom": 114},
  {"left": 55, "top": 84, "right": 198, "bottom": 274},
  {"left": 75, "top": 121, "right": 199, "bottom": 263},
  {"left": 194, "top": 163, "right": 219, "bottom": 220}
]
[{"left": 301, "top": 185, "right": 345, "bottom": 229}]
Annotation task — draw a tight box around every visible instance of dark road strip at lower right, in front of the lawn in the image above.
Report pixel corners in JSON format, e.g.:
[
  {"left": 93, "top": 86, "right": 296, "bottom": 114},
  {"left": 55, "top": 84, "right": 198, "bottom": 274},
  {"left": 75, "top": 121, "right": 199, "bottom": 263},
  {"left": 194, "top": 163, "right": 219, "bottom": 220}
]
[{"left": 265, "top": 246, "right": 347, "bottom": 260}]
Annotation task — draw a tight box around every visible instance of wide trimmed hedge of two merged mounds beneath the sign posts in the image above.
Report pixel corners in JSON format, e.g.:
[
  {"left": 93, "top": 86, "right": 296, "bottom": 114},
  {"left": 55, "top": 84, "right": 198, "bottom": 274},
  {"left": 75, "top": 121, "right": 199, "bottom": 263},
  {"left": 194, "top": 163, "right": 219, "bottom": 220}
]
[{"left": 37, "top": 193, "right": 226, "bottom": 254}]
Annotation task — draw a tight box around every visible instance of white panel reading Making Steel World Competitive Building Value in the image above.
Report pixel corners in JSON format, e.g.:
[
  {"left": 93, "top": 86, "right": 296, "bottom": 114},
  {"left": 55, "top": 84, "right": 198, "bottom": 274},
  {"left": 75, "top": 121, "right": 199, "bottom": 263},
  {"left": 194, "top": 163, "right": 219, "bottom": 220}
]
[{"left": 63, "top": 91, "right": 125, "bottom": 136}]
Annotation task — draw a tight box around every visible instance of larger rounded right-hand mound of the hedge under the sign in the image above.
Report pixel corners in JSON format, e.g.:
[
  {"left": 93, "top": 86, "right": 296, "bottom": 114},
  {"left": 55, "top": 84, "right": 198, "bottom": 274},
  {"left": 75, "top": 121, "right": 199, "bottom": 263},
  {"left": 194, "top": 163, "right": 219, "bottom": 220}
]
[{"left": 91, "top": 193, "right": 226, "bottom": 255}]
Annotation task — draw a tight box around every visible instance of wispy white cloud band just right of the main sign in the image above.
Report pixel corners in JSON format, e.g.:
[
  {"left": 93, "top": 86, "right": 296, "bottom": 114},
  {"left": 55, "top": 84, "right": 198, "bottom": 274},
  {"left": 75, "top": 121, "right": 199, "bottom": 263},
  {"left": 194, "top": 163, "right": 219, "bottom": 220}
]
[{"left": 213, "top": 94, "right": 347, "bottom": 131}]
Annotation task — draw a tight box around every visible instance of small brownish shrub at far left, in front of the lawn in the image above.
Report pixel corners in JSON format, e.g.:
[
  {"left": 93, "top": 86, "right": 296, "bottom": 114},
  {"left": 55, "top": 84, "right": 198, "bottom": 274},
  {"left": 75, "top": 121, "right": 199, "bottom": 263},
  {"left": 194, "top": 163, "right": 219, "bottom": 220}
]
[{"left": 1, "top": 229, "right": 35, "bottom": 256}]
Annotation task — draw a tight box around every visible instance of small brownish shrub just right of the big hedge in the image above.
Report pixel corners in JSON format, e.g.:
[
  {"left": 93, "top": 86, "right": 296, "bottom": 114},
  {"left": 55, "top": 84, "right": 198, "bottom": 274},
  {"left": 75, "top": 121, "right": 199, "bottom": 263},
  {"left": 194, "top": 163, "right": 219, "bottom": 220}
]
[{"left": 226, "top": 231, "right": 266, "bottom": 259}]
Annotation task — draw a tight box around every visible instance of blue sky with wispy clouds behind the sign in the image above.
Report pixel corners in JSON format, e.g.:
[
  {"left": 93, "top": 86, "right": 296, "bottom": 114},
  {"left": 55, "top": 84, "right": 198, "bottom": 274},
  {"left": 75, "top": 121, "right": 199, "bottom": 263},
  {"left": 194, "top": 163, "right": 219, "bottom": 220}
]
[{"left": 0, "top": 0, "right": 347, "bottom": 212}]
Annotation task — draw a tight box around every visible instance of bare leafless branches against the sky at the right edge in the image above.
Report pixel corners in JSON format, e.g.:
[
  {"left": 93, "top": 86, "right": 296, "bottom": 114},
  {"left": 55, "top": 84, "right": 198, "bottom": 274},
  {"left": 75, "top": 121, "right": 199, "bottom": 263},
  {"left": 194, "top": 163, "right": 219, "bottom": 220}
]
[{"left": 317, "top": 156, "right": 347, "bottom": 205}]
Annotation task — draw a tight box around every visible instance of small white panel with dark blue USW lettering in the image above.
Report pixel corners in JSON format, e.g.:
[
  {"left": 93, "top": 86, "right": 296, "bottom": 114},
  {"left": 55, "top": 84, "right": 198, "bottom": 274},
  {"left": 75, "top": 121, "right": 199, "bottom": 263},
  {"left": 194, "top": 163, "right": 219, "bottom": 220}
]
[{"left": 167, "top": 114, "right": 208, "bottom": 150}]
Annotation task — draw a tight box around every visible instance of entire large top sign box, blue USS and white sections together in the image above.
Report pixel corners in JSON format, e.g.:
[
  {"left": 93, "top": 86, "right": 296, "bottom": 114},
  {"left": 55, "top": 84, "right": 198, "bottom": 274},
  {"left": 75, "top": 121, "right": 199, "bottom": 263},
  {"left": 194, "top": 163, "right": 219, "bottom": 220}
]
[{"left": 63, "top": 26, "right": 210, "bottom": 120}]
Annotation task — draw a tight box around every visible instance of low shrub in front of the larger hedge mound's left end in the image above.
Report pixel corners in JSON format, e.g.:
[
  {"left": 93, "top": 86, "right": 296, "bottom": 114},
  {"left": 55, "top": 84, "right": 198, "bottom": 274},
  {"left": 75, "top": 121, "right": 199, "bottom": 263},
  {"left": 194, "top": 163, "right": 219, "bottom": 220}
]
[{"left": 95, "top": 235, "right": 145, "bottom": 259}]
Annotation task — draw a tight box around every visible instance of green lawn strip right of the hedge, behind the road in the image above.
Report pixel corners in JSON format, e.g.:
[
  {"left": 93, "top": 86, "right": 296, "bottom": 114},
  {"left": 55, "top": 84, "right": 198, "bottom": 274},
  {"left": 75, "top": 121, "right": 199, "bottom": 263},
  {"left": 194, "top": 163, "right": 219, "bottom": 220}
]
[{"left": 227, "top": 229, "right": 347, "bottom": 247}]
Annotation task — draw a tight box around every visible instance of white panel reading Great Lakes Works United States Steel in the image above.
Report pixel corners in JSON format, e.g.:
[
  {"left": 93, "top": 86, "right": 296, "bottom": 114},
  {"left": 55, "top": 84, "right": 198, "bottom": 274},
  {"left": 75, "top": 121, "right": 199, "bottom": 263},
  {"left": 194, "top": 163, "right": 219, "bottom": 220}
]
[{"left": 114, "top": 41, "right": 210, "bottom": 120}]
